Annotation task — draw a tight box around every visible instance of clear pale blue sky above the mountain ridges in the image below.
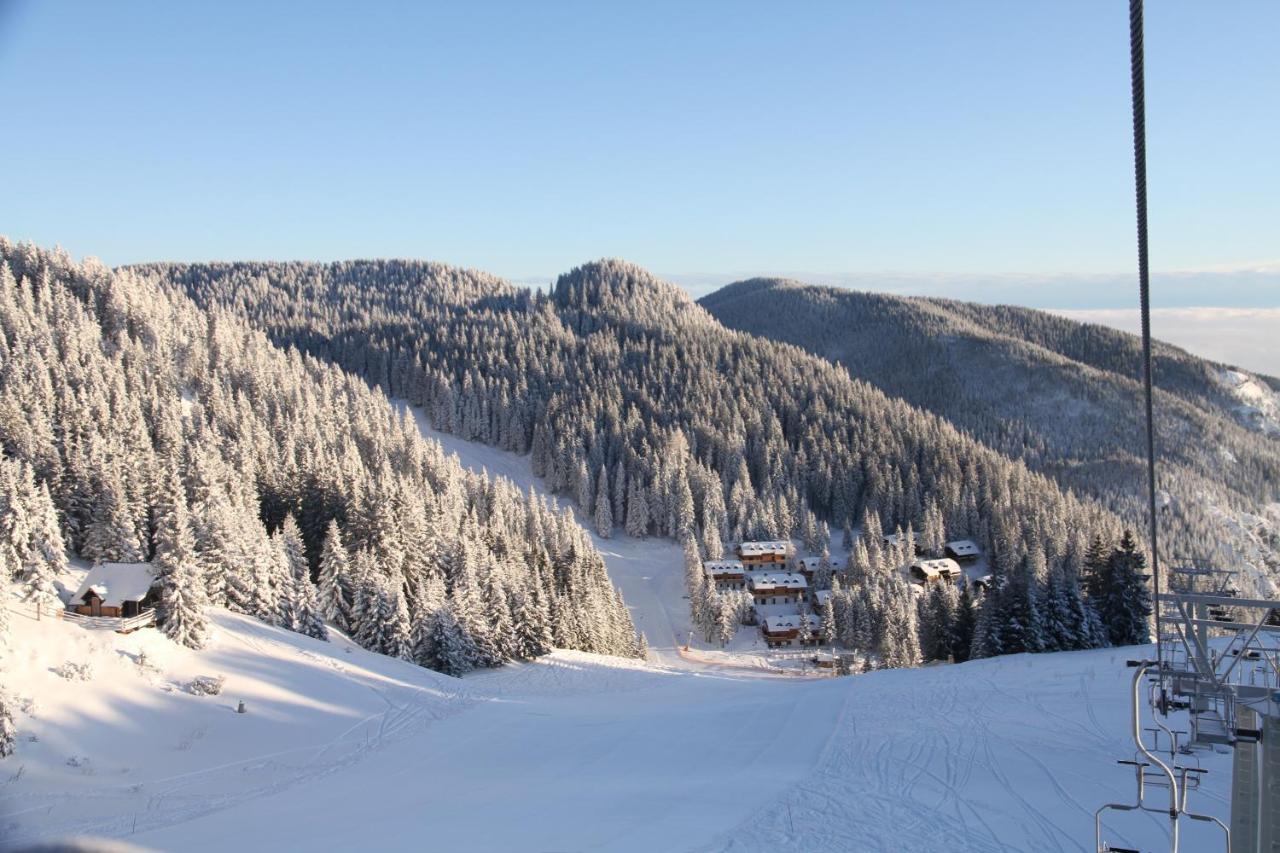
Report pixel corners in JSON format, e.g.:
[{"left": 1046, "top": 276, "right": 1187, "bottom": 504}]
[{"left": 0, "top": 0, "right": 1280, "bottom": 305}]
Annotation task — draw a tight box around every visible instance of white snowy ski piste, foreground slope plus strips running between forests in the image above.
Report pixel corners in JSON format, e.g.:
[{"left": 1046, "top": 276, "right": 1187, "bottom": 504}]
[{"left": 0, "top": 407, "right": 1230, "bottom": 853}]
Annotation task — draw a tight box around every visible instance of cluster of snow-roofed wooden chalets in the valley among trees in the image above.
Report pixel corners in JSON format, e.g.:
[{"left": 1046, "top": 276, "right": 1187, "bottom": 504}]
[{"left": 703, "top": 534, "right": 987, "bottom": 648}]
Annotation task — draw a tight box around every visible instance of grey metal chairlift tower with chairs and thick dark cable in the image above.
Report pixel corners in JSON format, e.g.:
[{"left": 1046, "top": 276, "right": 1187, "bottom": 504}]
[{"left": 1094, "top": 0, "right": 1280, "bottom": 853}]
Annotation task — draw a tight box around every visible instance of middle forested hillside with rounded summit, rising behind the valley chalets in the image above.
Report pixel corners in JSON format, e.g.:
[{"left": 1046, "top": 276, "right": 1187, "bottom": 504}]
[{"left": 134, "top": 261, "right": 1120, "bottom": 612}]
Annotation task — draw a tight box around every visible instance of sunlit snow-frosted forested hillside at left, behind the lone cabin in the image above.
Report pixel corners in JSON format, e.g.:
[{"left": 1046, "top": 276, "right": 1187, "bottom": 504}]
[{"left": 0, "top": 238, "right": 639, "bottom": 672}]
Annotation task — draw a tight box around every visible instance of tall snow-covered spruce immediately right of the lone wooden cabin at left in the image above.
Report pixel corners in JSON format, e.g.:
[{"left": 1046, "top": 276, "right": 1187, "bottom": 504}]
[{"left": 152, "top": 469, "right": 209, "bottom": 648}]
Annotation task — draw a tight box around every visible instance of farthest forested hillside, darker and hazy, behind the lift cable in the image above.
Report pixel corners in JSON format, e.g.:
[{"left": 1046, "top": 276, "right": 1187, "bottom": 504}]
[{"left": 700, "top": 279, "right": 1280, "bottom": 578}]
